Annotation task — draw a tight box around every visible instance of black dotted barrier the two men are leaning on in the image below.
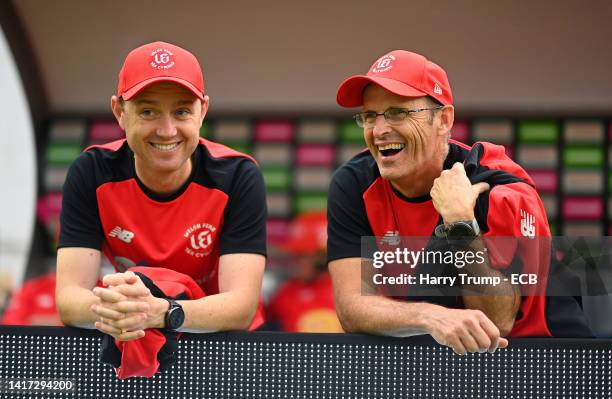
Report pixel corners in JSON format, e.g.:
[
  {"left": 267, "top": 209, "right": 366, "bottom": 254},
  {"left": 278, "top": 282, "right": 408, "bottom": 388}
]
[{"left": 0, "top": 326, "right": 612, "bottom": 399}]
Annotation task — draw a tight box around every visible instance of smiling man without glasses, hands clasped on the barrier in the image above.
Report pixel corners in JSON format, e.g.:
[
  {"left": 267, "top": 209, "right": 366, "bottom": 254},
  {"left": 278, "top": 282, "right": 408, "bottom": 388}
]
[{"left": 57, "top": 42, "right": 266, "bottom": 341}]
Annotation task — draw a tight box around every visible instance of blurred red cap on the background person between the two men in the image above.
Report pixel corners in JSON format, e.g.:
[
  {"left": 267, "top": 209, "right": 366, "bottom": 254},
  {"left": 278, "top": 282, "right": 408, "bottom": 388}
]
[{"left": 281, "top": 211, "right": 327, "bottom": 255}]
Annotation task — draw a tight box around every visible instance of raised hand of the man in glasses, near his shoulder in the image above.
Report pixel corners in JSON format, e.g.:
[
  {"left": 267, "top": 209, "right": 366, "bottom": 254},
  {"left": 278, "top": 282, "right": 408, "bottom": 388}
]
[{"left": 430, "top": 162, "right": 490, "bottom": 224}]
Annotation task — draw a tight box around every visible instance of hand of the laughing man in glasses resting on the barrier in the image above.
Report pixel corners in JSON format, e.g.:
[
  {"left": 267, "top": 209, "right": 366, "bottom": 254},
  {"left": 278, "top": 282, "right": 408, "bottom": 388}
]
[{"left": 427, "top": 307, "right": 508, "bottom": 355}]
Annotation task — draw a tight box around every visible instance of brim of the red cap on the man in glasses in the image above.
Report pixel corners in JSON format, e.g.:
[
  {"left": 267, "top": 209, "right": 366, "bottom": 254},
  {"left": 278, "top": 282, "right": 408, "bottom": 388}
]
[{"left": 336, "top": 75, "right": 427, "bottom": 108}]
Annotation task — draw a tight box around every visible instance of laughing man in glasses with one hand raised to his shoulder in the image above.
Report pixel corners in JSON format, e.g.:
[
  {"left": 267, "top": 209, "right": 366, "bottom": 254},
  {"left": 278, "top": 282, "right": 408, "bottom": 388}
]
[{"left": 328, "top": 50, "right": 592, "bottom": 354}]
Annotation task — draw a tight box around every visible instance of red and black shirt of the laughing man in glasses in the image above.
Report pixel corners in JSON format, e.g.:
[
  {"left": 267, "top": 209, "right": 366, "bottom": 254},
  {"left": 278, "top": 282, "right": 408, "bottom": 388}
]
[{"left": 328, "top": 140, "right": 564, "bottom": 336}]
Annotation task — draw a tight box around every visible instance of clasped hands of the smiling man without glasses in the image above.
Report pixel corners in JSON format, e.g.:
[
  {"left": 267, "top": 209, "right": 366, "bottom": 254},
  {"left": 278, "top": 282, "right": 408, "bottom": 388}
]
[{"left": 90, "top": 271, "right": 164, "bottom": 341}]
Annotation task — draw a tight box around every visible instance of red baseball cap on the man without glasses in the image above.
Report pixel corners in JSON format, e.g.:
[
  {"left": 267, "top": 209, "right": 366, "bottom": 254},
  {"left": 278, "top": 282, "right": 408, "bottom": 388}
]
[{"left": 117, "top": 42, "right": 204, "bottom": 101}]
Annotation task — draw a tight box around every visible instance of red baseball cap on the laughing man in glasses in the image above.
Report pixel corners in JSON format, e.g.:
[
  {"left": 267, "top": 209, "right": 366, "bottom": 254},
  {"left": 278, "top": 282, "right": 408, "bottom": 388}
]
[{"left": 336, "top": 50, "right": 453, "bottom": 108}]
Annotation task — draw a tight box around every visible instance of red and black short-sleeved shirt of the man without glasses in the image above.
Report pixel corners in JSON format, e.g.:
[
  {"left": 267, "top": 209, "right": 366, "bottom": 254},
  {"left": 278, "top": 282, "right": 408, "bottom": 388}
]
[{"left": 59, "top": 139, "right": 267, "bottom": 295}]
